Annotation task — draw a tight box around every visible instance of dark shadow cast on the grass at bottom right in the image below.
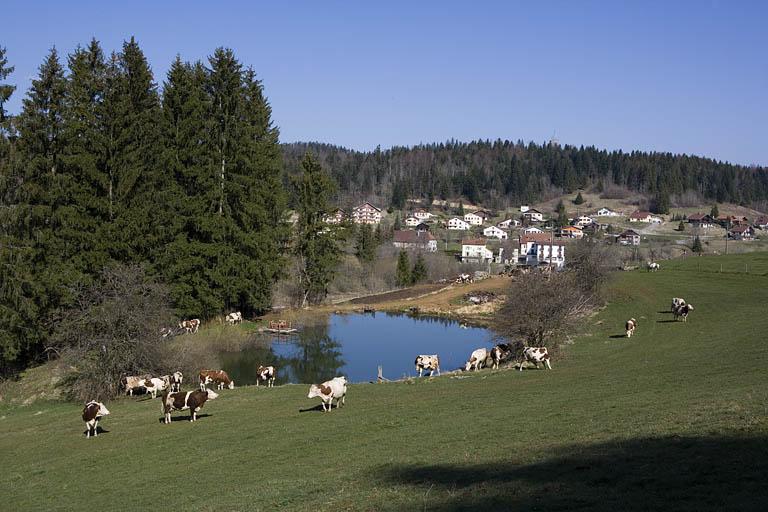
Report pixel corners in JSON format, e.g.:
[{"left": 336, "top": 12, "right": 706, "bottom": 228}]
[{"left": 371, "top": 436, "right": 768, "bottom": 512}]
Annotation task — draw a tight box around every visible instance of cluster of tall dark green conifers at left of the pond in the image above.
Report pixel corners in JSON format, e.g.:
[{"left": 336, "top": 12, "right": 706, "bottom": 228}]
[{"left": 0, "top": 39, "right": 288, "bottom": 374}]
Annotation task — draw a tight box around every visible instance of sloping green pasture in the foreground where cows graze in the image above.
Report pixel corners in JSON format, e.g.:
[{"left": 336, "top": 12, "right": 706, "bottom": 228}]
[{"left": 0, "top": 254, "right": 768, "bottom": 511}]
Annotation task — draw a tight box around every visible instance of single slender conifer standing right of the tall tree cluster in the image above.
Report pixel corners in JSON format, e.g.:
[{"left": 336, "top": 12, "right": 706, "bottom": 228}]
[{"left": 294, "top": 153, "right": 341, "bottom": 307}]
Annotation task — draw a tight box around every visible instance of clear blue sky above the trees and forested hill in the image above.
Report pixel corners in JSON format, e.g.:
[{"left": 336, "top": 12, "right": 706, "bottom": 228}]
[{"left": 0, "top": 0, "right": 768, "bottom": 165}]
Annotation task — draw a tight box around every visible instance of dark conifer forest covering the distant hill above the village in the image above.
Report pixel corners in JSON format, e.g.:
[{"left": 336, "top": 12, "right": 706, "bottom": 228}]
[{"left": 283, "top": 140, "right": 768, "bottom": 213}]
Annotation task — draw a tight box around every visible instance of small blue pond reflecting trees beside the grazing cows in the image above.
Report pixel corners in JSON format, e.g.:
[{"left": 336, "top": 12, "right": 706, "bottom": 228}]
[{"left": 219, "top": 313, "right": 493, "bottom": 384}]
